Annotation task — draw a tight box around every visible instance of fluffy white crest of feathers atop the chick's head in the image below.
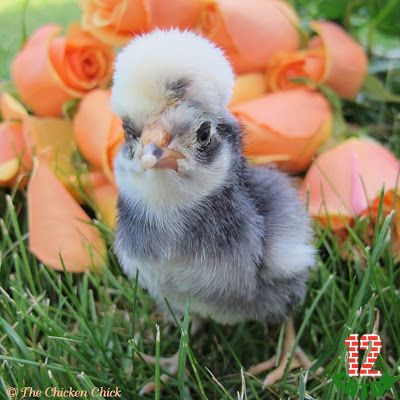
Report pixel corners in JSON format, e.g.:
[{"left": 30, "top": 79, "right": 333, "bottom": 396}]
[{"left": 111, "top": 29, "right": 234, "bottom": 124}]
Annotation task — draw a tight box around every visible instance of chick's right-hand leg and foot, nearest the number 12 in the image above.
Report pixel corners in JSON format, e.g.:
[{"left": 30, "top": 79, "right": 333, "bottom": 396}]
[{"left": 249, "top": 318, "right": 321, "bottom": 386}]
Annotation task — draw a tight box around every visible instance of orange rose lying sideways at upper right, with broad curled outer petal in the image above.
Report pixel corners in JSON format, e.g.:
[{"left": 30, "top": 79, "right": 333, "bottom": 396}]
[{"left": 266, "top": 21, "right": 368, "bottom": 98}]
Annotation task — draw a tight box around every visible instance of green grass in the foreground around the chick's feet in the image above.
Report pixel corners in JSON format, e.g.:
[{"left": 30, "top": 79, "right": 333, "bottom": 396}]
[{"left": 0, "top": 195, "right": 400, "bottom": 399}]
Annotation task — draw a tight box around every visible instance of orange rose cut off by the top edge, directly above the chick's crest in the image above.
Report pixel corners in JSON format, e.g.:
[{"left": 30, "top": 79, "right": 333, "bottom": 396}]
[{"left": 80, "top": 0, "right": 200, "bottom": 45}]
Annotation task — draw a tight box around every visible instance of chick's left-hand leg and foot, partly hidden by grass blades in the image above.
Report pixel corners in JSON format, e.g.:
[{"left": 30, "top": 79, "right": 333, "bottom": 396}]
[{"left": 138, "top": 316, "right": 203, "bottom": 395}]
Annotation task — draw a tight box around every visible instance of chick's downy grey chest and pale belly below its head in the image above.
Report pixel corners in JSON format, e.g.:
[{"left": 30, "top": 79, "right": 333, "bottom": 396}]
[{"left": 115, "top": 194, "right": 262, "bottom": 310}]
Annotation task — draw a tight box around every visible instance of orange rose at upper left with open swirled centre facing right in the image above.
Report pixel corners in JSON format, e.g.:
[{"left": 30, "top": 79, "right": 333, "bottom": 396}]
[{"left": 11, "top": 24, "right": 114, "bottom": 116}]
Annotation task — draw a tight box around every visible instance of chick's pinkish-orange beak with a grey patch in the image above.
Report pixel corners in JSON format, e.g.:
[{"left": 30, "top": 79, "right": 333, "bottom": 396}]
[{"left": 141, "top": 121, "right": 184, "bottom": 171}]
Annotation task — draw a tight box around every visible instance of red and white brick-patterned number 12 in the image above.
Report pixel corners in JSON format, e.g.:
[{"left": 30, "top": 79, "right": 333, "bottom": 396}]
[{"left": 344, "top": 334, "right": 382, "bottom": 377}]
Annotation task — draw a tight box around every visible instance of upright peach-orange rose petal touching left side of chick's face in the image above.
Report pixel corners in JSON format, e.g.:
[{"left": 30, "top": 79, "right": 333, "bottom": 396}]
[{"left": 74, "top": 90, "right": 123, "bottom": 180}]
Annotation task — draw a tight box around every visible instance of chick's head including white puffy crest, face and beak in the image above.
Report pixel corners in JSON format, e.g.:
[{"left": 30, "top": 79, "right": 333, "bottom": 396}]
[{"left": 112, "top": 29, "right": 240, "bottom": 205}]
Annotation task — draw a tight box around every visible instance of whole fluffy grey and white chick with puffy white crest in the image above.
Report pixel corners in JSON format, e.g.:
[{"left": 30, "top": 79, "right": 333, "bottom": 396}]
[{"left": 112, "top": 30, "right": 314, "bottom": 390}]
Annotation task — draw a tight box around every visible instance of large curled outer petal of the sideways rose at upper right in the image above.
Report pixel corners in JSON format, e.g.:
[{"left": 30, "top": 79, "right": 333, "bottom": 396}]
[{"left": 310, "top": 21, "right": 368, "bottom": 98}]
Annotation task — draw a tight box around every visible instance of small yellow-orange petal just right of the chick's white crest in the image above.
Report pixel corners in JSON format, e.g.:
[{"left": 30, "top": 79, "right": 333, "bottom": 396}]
[{"left": 230, "top": 73, "right": 266, "bottom": 106}]
